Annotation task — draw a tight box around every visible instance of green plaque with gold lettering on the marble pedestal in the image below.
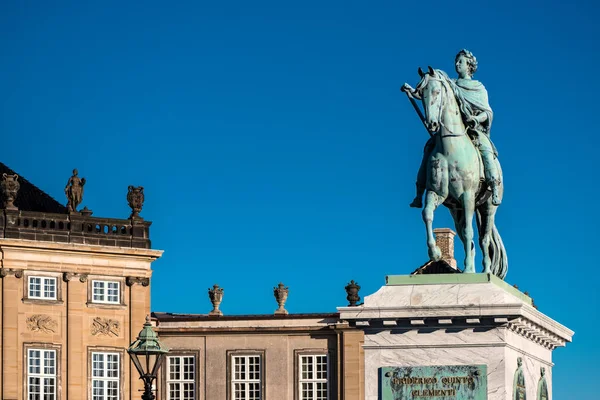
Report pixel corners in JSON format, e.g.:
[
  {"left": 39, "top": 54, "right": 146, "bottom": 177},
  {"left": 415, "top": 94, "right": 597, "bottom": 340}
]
[{"left": 379, "top": 365, "right": 487, "bottom": 400}]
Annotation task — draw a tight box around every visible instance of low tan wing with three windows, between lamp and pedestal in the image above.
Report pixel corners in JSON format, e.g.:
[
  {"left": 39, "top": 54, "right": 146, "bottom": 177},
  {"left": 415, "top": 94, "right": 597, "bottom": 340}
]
[{"left": 153, "top": 313, "right": 364, "bottom": 400}]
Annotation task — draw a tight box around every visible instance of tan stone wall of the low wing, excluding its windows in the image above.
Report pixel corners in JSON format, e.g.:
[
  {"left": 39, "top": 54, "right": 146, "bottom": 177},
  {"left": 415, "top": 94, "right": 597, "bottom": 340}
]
[{"left": 157, "top": 314, "right": 364, "bottom": 400}]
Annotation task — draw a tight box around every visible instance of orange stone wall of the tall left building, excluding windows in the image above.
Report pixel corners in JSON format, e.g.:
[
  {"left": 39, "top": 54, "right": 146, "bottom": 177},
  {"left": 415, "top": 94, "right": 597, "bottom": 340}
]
[{"left": 0, "top": 239, "right": 162, "bottom": 400}]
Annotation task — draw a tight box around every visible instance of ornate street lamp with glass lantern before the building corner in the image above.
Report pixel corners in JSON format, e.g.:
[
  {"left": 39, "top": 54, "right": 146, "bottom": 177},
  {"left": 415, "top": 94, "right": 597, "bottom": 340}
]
[{"left": 127, "top": 315, "right": 169, "bottom": 400}]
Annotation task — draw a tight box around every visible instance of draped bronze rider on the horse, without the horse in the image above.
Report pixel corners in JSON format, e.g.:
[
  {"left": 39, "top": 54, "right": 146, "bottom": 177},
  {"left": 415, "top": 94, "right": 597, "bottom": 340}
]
[{"left": 402, "top": 50, "right": 501, "bottom": 208}]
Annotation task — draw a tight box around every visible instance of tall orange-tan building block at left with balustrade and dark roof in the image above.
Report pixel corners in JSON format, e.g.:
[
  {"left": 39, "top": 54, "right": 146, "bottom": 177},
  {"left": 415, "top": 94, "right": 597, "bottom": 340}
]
[{"left": 0, "top": 164, "right": 162, "bottom": 400}]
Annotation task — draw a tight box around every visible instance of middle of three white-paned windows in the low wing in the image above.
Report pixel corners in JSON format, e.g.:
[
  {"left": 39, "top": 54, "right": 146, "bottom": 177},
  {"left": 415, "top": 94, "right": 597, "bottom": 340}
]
[{"left": 231, "top": 355, "right": 262, "bottom": 400}]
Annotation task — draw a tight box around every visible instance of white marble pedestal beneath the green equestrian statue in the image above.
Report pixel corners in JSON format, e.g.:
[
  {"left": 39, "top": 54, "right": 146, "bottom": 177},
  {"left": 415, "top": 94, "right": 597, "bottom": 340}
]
[{"left": 338, "top": 274, "right": 573, "bottom": 400}]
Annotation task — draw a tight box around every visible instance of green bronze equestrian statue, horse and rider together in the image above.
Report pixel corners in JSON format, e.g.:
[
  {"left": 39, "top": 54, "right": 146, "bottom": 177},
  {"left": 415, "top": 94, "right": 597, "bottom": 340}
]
[{"left": 401, "top": 50, "right": 508, "bottom": 279}]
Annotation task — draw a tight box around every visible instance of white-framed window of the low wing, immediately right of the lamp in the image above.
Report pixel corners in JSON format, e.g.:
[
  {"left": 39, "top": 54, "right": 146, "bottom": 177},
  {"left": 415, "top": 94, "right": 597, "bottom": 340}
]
[{"left": 167, "top": 356, "right": 196, "bottom": 400}]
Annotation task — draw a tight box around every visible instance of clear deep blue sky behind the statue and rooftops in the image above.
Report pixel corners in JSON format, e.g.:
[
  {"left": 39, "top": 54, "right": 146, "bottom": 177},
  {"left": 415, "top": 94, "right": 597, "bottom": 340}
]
[{"left": 0, "top": 1, "right": 600, "bottom": 399}]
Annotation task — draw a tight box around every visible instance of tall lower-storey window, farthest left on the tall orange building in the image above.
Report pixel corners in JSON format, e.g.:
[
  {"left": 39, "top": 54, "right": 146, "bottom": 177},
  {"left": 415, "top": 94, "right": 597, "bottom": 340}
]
[{"left": 27, "top": 349, "right": 56, "bottom": 400}]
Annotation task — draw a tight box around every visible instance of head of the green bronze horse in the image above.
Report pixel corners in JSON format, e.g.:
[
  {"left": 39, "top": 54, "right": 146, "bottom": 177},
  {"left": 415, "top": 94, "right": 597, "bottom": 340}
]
[{"left": 416, "top": 67, "right": 445, "bottom": 133}]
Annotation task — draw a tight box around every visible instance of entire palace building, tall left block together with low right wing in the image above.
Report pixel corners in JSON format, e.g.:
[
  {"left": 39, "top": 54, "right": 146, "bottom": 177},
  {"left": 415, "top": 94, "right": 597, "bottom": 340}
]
[{"left": 0, "top": 163, "right": 364, "bottom": 400}]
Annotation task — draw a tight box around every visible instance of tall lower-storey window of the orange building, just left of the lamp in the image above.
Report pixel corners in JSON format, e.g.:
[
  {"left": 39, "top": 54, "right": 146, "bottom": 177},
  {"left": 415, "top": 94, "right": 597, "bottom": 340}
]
[{"left": 92, "top": 353, "right": 120, "bottom": 400}]
